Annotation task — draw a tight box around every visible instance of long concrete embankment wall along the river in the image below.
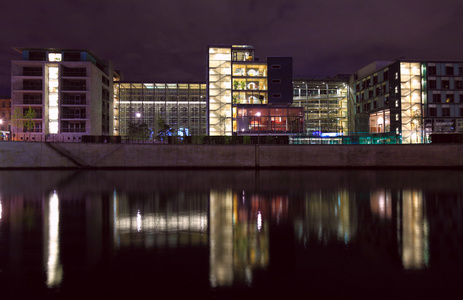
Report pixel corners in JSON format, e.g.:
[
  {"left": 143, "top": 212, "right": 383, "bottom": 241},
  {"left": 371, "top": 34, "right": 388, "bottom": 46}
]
[{"left": 0, "top": 142, "right": 463, "bottom": 168}]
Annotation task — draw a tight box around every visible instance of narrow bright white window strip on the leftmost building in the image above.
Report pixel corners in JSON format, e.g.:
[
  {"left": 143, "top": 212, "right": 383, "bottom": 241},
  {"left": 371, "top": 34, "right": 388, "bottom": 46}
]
[{"left": 47, "top": 64, "right": 59, "bottom": 134}]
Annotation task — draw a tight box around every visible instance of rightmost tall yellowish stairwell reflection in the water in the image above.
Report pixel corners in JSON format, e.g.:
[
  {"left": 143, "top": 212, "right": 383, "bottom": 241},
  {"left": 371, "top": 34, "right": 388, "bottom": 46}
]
[{"left": 398, "top": 190, "right": 429, "bottom": 269}]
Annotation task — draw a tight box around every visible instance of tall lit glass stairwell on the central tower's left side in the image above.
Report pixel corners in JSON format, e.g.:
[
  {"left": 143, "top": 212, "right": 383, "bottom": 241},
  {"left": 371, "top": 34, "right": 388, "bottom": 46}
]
[{"left": 208, "top": 48, "right": 232, "bottom": 136}]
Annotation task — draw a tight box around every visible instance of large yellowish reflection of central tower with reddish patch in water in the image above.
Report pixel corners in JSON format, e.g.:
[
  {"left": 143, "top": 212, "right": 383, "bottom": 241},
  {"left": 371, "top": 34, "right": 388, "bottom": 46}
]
[{"left": 210, "top": 191, "right": 293, "bottom": 287}]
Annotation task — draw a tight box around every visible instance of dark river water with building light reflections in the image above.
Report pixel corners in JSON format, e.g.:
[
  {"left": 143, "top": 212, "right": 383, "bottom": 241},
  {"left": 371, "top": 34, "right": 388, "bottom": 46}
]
[{"left": 0, "top": 170, "right": 463, "bottom": 299}]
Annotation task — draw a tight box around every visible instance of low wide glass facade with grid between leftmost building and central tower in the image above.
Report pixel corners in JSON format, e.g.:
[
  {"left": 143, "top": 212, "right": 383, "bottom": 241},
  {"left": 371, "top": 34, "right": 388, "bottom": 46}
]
[{"left": 113, "top": 82, "right": 207, "bottom": 139}]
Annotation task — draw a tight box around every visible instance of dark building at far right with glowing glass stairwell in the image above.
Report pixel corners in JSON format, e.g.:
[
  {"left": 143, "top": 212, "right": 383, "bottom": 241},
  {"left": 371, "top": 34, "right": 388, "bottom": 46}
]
[{"left": 350, "top": 60, "right": 463, "bottom": 144}]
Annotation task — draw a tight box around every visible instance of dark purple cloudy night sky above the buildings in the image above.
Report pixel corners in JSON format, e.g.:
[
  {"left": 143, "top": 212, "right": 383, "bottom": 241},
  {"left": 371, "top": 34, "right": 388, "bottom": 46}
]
[{"left": 0, "top": 0, "right": 463, "bottom": 95}]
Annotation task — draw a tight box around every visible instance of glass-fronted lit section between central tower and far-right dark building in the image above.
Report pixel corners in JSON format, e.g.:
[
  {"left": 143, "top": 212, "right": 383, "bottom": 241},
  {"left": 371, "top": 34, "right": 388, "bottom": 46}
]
[{"left": 293, "top": 76, "right": 349, "bottom": 138}]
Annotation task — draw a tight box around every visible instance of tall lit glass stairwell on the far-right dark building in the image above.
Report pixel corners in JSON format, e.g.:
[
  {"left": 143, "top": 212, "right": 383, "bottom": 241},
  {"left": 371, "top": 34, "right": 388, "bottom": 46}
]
[{"left": 400, "top": 62, "right": 421, "bottom": 144}]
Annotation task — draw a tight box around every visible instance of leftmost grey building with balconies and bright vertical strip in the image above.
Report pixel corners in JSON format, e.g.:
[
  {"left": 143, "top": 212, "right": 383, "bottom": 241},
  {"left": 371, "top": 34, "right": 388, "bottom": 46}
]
[{"left": 11, "top": 48, "right": 118, "bottom": 141}]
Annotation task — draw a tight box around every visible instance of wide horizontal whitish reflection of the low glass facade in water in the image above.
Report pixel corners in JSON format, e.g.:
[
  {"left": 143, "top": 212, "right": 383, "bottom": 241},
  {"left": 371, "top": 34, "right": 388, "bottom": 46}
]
[{"left": 112, "top": 193, "right": 208, "bottom": 248}]
